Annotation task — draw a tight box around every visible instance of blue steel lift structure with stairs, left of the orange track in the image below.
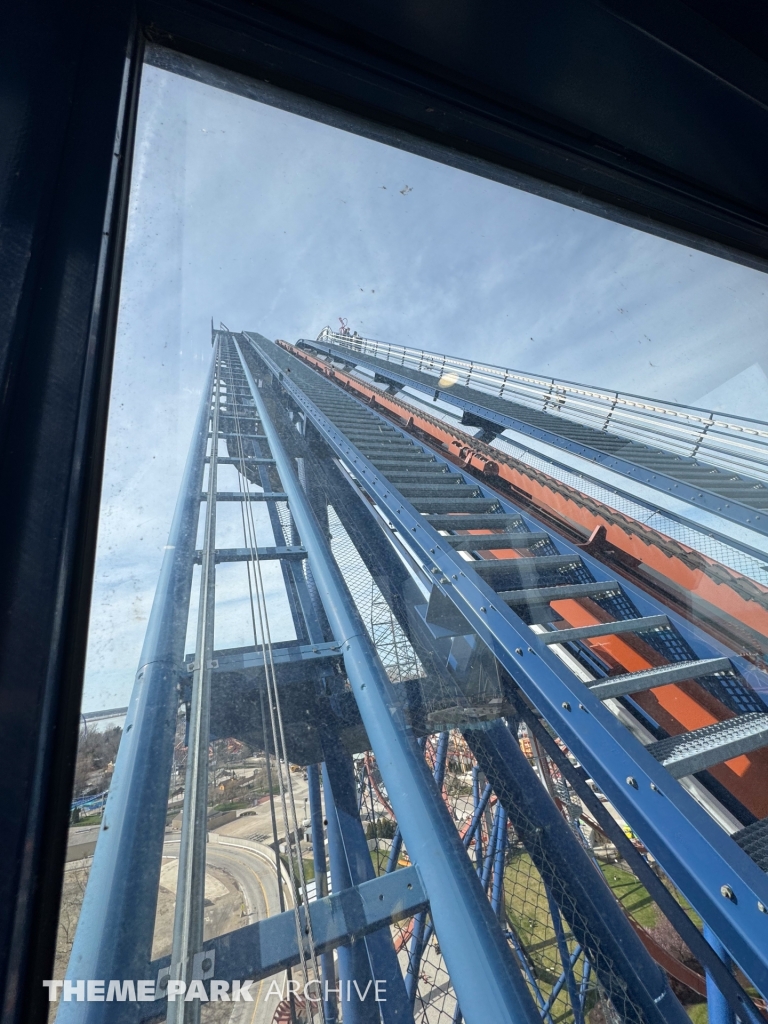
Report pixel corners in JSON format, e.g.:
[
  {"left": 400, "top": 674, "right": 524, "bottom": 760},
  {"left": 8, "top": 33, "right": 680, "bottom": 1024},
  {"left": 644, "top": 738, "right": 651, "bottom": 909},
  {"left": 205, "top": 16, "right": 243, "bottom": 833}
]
[{"left": 59, "top": 330, "right": 768, "bottom": 1024}]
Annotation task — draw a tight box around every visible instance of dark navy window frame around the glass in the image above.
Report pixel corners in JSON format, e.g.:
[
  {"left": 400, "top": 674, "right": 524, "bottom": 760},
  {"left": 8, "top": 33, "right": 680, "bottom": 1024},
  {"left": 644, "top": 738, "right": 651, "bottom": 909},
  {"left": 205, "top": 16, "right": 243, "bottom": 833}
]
[{"left": 0, "top": 0, "right": 768, "bottom": 1022}]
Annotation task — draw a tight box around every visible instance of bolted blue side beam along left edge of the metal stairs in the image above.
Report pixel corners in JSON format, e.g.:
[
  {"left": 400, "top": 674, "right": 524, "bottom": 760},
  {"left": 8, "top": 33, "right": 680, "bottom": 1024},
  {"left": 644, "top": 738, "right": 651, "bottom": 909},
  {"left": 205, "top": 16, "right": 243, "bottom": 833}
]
[{"left": 254, "top": 343, "right": 768, "bottom": 995}]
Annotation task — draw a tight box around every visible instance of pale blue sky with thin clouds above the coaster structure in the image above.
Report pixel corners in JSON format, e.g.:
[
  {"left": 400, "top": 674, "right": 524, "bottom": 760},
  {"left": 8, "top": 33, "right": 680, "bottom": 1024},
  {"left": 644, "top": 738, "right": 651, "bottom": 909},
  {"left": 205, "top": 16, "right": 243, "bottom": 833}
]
[{"left": 83, "top": 67, "right": 768, "bottom": 711}]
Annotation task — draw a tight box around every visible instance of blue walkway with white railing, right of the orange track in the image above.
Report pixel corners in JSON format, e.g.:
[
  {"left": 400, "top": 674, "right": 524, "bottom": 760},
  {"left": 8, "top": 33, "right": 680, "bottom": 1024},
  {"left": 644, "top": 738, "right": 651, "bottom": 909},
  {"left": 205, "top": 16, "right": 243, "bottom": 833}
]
[{"left": 300, "top": 331, "right": 768, "bottom": 536}]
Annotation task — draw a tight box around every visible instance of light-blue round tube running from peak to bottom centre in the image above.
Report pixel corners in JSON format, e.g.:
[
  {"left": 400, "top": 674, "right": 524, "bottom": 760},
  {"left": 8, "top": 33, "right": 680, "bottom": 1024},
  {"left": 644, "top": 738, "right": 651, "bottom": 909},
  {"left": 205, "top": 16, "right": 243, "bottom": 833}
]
[{"left": 239, "top": 346, "right": 539, "bottom": 1024}]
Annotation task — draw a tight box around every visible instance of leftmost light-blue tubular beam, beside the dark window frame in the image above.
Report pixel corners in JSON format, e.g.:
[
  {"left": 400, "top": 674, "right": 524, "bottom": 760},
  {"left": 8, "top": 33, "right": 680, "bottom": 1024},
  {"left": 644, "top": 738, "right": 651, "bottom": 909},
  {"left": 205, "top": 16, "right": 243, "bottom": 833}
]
[{"left": 57, "top": 350, "right": 214, "bottom": 1024}]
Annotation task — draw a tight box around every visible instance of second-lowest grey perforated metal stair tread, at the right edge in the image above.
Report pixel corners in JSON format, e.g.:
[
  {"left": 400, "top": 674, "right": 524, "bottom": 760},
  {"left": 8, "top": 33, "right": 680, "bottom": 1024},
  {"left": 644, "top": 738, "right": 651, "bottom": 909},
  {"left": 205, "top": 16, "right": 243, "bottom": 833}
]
[{"left": 646, "top": 712, "right": 768, "bottom": 778}]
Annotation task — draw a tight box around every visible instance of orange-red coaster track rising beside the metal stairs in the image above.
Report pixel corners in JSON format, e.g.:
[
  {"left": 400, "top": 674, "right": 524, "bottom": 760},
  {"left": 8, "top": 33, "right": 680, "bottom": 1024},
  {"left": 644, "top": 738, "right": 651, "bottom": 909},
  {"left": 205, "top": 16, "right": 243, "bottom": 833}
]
[{"left": 278, "top": 341, "right": 768, "bottom": 818}]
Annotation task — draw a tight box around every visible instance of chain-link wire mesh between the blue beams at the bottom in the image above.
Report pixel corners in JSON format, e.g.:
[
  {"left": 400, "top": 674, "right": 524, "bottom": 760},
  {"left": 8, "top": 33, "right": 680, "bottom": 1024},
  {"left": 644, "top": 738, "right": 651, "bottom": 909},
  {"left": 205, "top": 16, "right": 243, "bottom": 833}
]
[{"left": 358, "top": 724, "right": 729, "bottom": 1024}]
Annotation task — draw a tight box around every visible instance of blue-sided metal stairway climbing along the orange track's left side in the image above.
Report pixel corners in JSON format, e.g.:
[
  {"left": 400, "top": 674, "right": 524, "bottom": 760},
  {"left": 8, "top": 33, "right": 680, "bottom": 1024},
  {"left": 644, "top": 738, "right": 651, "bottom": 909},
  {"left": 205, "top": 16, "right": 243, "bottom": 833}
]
[{"left": 240, "top": 336, "right": 766, "bottom": 1007}]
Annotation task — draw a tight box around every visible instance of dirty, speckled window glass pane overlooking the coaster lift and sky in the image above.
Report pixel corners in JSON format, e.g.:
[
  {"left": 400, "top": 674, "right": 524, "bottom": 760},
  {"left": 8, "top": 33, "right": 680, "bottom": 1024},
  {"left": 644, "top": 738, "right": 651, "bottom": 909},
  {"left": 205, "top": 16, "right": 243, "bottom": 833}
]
[{"left": 55, "top": 44, "right": 768, "bottom": 1024}]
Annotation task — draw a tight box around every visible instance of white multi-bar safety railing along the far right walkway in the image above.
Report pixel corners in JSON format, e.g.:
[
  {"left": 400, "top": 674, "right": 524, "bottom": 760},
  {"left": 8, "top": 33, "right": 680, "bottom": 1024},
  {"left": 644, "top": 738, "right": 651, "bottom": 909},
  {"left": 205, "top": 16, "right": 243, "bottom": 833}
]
[{"left": 317, "top": 328, "right": 768, "bottom": 480}]
